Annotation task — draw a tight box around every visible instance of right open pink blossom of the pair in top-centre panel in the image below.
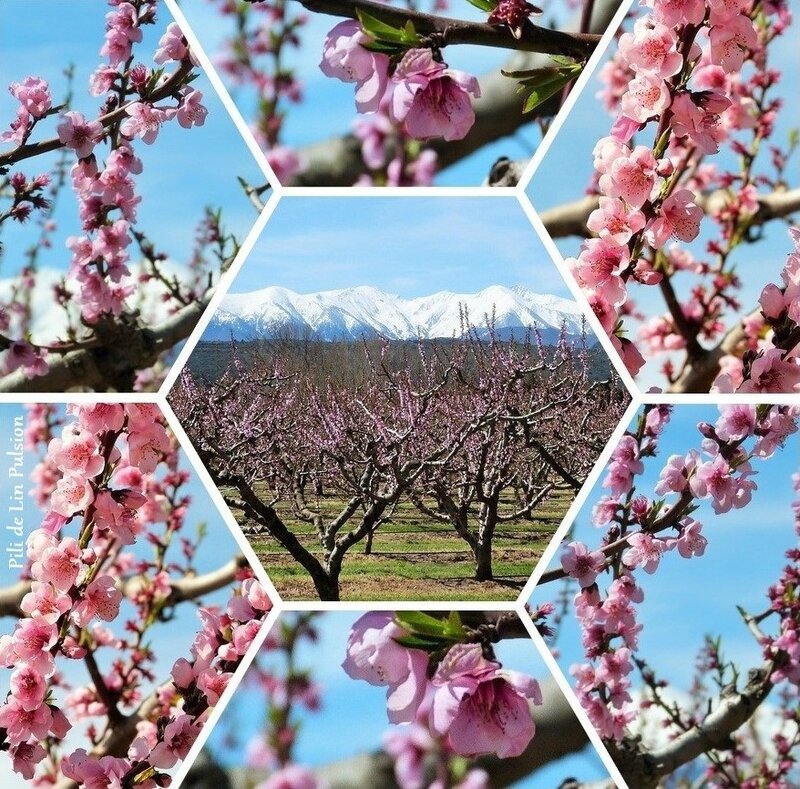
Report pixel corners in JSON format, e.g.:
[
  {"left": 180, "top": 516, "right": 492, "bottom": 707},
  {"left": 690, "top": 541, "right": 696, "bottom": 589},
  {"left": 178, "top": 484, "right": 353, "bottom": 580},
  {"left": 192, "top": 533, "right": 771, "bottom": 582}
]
[{"left": 389, "top": 49, "right": 480, "bottom": 140}]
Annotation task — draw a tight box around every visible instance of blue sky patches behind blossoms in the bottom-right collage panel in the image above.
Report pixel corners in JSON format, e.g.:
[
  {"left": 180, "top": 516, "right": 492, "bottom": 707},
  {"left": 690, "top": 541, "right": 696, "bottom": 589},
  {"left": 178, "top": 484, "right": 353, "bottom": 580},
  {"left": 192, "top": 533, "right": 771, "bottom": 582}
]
[{"left": 533, "top": 405, "right": 800, "bottom": 690}]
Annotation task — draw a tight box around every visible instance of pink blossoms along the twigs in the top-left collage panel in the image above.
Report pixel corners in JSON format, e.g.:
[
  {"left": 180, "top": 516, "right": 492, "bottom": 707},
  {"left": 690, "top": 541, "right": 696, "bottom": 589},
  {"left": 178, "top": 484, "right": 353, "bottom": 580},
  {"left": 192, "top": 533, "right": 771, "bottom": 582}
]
[{"left": 0, "top": 0, "right": 207, "bottom": 384}]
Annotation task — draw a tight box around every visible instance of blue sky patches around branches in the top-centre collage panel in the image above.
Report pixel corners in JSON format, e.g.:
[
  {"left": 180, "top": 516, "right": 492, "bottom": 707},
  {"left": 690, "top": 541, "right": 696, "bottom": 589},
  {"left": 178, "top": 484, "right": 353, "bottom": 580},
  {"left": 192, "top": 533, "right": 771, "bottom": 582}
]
[{"left": 181, "top": 0, "right": 580, "bottom": 186}]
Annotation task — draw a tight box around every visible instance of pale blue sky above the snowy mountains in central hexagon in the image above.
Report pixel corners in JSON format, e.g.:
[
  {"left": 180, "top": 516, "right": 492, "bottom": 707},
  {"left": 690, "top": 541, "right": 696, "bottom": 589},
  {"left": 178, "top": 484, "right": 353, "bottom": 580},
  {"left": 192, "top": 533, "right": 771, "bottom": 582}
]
[{"left": 230, "top": 196, "right": 570, "bottom": 298}]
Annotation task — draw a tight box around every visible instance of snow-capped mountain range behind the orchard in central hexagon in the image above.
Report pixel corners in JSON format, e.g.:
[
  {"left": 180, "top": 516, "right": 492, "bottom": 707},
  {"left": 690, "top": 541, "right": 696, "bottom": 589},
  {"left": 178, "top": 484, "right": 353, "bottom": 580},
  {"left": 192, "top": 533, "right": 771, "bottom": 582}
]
[{"left": 203, "top": 285, "right": 581, "bottom": 342}]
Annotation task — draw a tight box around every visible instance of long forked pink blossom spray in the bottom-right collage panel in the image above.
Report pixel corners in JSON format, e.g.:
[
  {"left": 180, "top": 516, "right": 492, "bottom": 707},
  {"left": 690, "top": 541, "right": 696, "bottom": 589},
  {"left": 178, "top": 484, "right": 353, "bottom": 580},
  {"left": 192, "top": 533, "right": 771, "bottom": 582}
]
[{"left": 561, "top": 405, "right": 800, "bottom": 740}]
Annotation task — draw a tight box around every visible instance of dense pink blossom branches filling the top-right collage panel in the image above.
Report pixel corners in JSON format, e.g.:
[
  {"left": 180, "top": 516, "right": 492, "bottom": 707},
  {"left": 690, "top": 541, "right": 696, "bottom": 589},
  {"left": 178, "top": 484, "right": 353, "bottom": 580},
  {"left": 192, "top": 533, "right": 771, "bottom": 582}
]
[{"left": 567, "top": 0, "right": 797, "bottom": 391}]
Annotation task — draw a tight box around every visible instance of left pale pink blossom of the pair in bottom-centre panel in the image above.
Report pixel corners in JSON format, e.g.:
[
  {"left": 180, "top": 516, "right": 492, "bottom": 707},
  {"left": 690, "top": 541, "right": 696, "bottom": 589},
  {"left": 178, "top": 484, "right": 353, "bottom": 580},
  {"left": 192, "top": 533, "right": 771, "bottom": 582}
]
[{"left": 342, "top": 611, "right": 428, "bottom": 723}]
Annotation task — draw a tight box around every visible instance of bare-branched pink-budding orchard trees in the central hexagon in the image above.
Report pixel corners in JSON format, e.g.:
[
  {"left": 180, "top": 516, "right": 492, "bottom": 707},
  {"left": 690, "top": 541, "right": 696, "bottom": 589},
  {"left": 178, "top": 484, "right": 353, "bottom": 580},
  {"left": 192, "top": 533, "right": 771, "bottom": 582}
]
[{"left": 172, "top": 329, "right": 625, "bottom": 600}]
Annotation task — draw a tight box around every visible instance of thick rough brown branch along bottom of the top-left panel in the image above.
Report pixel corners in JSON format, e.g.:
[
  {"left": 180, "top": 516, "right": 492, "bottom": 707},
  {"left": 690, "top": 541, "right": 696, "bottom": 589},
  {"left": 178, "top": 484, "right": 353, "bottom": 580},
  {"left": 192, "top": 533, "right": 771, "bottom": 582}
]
[{"left": 0, "top": 291, "right": 212, "bottom": 392}]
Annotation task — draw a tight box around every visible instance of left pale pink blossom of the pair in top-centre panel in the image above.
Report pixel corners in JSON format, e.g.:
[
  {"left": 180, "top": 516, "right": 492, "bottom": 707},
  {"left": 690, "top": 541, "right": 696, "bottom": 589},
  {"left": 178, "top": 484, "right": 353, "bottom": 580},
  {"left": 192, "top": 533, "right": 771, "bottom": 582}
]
[{"left": 319, "top": 20, "right": 389, "bottom": 112}]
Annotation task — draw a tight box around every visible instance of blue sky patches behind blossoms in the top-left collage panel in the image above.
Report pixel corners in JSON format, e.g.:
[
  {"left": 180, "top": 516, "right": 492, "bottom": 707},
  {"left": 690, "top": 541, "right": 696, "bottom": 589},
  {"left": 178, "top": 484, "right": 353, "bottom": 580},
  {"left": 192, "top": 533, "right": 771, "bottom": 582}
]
[{"left": 0, "top": 0, "right": 265, "bottom": 277}]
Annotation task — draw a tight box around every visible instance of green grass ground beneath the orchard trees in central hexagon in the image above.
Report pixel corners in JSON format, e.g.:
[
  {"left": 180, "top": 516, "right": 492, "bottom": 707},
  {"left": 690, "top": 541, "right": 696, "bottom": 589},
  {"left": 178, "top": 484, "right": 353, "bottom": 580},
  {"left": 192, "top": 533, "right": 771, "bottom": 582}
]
[{"left": 227, "top": 484, "right": 572, "bottom": 600}]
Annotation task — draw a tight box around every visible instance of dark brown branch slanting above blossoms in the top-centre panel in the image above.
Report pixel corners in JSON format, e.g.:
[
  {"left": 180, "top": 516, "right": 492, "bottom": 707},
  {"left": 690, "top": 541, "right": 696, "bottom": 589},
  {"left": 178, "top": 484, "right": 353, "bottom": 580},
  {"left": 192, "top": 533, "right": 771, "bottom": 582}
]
[{"left": 300, "top": 0, "right": 600, "bottom": 58}]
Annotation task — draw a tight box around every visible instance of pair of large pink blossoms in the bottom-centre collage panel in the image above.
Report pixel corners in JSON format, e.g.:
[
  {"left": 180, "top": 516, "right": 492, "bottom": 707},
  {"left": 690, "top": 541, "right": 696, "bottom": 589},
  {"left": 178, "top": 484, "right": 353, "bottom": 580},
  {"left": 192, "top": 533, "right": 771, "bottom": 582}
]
[{"left": 342, "top": 612, "right": 542, "bottom": 758}]
